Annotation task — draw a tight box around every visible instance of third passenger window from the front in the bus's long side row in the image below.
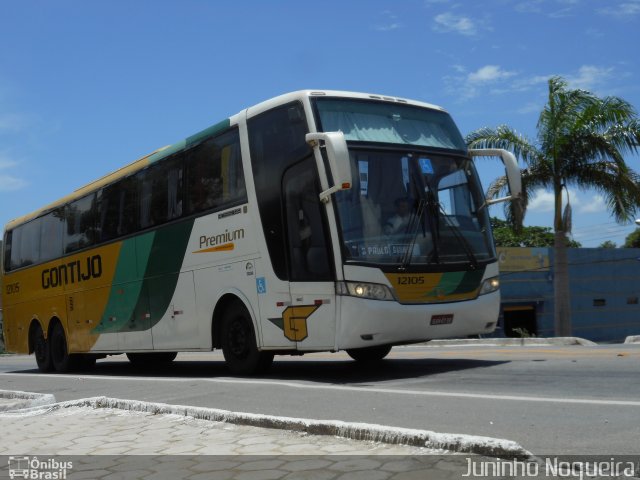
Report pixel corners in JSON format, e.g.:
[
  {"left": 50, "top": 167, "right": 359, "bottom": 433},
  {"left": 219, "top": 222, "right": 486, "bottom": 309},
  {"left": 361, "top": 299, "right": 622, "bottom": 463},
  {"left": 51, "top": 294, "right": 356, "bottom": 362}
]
[{"left": 98, "top": 177, "right": 136, "bottom": 242}]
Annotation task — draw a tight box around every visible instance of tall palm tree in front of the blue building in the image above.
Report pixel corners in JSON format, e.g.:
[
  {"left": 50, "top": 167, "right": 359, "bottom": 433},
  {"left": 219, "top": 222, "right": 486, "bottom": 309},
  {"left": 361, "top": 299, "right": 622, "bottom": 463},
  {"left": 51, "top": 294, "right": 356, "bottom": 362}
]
[{"left": 467, "top": 77, "right": 640, "bottom": 336}]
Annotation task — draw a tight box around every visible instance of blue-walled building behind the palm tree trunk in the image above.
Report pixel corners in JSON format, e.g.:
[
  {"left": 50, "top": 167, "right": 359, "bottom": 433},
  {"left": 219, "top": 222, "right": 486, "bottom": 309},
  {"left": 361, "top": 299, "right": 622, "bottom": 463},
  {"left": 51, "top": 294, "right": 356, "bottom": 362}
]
[{"left": 496, "top": 248, "right": 640, "bottom": 342}]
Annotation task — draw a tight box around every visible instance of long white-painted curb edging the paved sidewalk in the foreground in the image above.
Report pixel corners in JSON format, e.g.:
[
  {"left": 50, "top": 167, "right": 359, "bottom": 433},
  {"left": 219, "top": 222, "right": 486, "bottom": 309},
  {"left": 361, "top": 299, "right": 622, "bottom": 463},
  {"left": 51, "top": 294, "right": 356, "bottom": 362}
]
[{"left": 6, "top": 397, "right": 533, "bottom": 459}]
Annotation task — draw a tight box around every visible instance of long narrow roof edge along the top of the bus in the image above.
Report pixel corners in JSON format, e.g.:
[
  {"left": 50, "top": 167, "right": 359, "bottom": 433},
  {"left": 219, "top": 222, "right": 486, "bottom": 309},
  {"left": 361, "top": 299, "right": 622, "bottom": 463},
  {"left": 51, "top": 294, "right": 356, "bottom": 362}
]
[{"left": 5, "top": 90, "right": 445, "bottom": 230}]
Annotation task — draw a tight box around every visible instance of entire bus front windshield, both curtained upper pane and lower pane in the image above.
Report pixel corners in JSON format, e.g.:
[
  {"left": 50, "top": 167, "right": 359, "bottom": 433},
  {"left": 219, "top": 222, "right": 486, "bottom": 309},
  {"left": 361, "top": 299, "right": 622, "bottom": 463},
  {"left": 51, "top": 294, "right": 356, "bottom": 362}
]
[{"left": 316, "top": 98, "right": 495, "bottom": 269}]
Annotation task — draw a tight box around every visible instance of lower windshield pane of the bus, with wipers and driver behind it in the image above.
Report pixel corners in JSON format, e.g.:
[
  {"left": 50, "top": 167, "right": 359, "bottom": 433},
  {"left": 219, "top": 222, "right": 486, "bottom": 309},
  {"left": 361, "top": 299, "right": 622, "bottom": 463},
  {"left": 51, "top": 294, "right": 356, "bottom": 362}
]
[{"left": 335, "top": 149, "right": 495, "bottom": 267}]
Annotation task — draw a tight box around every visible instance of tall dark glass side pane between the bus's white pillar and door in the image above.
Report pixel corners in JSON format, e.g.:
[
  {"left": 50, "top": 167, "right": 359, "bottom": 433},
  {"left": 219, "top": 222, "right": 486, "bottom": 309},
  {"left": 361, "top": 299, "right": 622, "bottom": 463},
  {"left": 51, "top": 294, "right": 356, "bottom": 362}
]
[{"left": 248, "top": 102, "right": 315, "bottom": 280}]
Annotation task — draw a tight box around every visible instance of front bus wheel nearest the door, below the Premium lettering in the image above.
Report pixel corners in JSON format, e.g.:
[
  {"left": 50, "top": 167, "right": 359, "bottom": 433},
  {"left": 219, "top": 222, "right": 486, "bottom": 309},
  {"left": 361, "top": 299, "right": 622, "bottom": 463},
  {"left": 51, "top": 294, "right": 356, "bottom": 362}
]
[{"left": 221, "top": 302, "right": 273, "bottom": 375}]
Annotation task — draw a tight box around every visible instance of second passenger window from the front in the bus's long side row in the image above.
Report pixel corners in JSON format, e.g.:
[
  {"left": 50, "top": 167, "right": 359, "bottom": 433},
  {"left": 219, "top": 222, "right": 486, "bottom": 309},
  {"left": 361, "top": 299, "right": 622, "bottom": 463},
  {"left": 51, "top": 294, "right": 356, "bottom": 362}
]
[{"left": 136, "top": 156, "right": 184, "bottom": 228}]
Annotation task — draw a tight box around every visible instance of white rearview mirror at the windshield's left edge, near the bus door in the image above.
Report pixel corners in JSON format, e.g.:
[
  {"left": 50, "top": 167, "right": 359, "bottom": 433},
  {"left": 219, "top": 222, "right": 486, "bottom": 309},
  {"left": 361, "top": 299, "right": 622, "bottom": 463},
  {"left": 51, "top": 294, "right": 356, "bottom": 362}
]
[{"left": 305, "top": 132, "right": 351, "bottom": 203}]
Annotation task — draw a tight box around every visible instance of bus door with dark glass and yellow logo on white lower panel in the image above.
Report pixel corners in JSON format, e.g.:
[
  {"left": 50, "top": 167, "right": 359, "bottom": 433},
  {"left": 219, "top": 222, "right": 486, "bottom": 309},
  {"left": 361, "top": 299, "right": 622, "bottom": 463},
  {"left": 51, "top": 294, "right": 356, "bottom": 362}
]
[{"left": 282, "top": 156, "right": 336, "bottom": 350}]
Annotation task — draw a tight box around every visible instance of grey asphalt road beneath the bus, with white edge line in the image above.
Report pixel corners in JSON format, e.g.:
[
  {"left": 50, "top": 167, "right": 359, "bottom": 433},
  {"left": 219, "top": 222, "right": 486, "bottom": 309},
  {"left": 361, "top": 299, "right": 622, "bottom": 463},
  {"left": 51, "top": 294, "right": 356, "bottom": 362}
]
[{"left": 0, "top": 345, "right": 640, "bottom": 455}]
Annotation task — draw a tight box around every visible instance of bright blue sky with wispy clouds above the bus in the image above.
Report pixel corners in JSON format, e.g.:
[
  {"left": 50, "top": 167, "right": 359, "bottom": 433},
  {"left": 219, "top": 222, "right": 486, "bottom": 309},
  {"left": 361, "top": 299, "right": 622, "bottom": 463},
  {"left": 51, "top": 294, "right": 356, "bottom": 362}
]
[{"left": 0, "top": 0, "right": 640, "bottom": 246}]
